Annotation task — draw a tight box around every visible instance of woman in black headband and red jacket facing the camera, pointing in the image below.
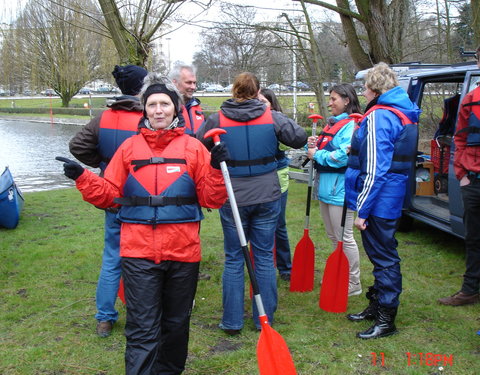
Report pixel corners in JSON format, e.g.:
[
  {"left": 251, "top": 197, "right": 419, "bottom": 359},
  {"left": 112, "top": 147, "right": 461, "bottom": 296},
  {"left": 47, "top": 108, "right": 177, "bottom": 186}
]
[{"left": 59, "top": 73, "right": 229, "bottom": 375}]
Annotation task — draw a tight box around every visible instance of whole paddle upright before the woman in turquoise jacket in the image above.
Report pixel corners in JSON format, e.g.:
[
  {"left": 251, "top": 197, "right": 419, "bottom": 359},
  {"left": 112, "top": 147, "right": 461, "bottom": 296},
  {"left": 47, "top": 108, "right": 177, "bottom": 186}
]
[{"left": 290, "top": 115, "right": 323, "bottom": 292}]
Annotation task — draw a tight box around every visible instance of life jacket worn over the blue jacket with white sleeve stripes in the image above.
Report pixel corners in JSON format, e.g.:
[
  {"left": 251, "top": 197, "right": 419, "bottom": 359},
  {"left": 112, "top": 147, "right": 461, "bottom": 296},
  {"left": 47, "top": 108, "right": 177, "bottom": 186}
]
[{"left": 348, "top": 104, "right": 418, "bottom": 175}]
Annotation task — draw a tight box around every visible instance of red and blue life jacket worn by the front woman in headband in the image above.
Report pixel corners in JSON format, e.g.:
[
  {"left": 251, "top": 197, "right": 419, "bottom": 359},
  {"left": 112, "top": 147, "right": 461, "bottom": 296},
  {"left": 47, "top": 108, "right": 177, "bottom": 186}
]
[{"left": 115, "top": 134, "right": 203, "bottom": 225}]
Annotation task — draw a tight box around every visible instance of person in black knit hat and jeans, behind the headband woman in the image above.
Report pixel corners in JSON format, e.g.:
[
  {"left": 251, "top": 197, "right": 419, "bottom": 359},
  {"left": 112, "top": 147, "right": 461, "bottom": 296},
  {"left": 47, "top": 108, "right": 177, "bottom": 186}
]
[{"left": 69, "top": 65, "right": 147, "bottom": 337}]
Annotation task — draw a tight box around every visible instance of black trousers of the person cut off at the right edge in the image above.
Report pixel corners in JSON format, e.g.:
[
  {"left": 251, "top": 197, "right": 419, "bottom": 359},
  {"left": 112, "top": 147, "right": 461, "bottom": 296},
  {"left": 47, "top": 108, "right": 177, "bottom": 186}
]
[{"left": 460, "top": 178, "right": 480, "bottom": 294}]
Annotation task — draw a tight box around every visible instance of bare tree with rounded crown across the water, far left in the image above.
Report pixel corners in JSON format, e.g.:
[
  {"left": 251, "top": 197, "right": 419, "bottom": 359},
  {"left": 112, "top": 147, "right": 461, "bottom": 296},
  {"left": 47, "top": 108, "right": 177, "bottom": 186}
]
[{"left": 8, "top": 0, "right": 106, "bottom": 107}]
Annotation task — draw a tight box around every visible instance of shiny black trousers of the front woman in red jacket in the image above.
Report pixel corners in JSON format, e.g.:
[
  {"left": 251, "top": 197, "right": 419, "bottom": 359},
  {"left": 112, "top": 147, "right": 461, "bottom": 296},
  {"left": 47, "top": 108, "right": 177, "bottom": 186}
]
[{"left": 122, "top": 258, "right": 199, "bottom": 375}]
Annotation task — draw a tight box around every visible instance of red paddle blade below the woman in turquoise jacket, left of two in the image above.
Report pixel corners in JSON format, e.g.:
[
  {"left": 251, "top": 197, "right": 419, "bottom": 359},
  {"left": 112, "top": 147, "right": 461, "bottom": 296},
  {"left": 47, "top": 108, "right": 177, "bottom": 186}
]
[{"left": 290, "top": 229, "right": 315, "bottom": 292}]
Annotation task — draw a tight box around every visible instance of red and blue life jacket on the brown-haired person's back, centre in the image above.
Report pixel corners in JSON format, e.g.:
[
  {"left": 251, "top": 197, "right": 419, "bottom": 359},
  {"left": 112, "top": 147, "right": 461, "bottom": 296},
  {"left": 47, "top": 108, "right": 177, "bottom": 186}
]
[{"left": 219, "top": 108, "right": 278, "bottom": 177}]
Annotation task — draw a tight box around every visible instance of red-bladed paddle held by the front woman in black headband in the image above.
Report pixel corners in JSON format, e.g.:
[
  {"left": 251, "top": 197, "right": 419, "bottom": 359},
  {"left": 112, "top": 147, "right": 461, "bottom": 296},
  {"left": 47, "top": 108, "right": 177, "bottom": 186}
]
[{"left": 204, "top": 128, "right": 297, "bottom": 375}]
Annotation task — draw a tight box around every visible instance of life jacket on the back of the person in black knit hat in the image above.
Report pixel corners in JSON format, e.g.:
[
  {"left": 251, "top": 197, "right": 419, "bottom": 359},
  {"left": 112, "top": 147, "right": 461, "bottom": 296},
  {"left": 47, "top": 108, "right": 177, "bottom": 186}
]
[{"left": 97, "top": 109, "right": 142, "bottom": 171}]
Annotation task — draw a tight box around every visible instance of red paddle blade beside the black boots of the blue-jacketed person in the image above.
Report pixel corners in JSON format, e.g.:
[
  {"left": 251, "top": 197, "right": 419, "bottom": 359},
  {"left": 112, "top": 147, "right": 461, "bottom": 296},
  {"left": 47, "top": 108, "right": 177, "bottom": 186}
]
[{"left": 318, "top": 241, "right": 349, "bottom": 313}]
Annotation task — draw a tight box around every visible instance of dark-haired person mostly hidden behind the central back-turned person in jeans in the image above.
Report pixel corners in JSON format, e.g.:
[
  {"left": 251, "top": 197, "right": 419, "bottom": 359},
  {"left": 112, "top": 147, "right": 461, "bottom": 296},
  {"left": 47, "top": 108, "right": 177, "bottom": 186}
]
[{"left": 258, "top": 88, "right": 292, "bottom": 281}]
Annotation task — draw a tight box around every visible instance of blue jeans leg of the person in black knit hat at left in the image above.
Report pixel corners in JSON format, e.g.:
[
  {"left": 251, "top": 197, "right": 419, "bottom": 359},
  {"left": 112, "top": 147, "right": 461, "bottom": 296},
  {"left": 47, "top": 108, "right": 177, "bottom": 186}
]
[{"left": 95, "top": 211, "right": 122, "bottom": 323}]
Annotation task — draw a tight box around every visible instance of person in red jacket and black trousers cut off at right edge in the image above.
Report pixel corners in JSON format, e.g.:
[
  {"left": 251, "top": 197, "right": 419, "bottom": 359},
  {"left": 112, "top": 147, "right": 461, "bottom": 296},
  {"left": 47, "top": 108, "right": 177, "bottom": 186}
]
[{"left": 438, "top": 46, "right": 480, "bottom": 314}]
